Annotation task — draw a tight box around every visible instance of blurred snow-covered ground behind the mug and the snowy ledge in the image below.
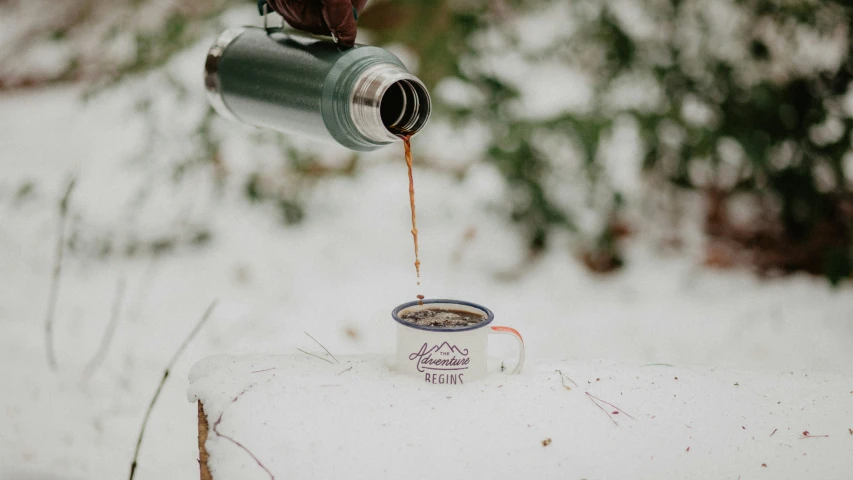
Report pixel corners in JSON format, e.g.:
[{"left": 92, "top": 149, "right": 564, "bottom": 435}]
[{"left": 0, "top": 56, "right": 853, "bottom": 480}]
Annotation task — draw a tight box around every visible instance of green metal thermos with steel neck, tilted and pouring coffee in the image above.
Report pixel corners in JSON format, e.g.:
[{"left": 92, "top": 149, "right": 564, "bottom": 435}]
[{"left": 204, "top": 27, "right": 430, "bottom": 151}]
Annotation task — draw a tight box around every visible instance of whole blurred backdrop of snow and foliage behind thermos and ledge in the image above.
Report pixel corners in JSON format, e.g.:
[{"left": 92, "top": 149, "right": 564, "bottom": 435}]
[{"left": 0, "top": 0, "right": 853, "bottom": 479}]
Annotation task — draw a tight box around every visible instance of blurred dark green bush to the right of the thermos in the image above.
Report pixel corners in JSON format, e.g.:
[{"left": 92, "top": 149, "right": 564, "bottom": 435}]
[{"left": 363, "top": 0, "right": 853, "bottom": 282}]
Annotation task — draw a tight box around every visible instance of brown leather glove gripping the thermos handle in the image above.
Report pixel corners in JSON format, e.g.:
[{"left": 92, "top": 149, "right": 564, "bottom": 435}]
[{"left": 267, "top": 0, "right": 367, "bottom": 47}]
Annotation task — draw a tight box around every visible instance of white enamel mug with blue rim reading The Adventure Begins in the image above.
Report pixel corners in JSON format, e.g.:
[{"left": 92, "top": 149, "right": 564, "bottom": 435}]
[{"left": 391, "top": 300, "right": 524, "bottom": 385}]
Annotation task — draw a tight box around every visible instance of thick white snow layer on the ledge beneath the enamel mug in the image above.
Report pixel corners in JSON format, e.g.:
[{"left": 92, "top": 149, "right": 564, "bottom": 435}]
[{"left": 189, "top": 348, "right": 853, "bottom": 480}]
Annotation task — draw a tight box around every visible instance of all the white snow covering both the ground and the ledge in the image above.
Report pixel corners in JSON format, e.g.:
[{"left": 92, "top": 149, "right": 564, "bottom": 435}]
[{"left": 0, "top": 6, "right": 853, "bottom": 480}]
